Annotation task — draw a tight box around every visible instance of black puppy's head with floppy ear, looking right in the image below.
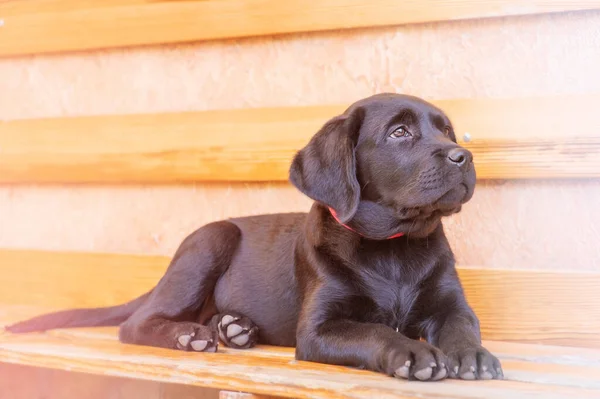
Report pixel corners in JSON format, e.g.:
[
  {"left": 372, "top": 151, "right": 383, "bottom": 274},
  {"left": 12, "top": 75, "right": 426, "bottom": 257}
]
[{"left": 290, "top": 94, "right": 475, "bottom": 238}]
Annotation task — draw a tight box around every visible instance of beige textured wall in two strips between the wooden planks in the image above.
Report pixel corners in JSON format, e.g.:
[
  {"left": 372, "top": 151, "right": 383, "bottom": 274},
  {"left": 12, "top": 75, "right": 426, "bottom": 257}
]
[{"left": 0, "top": 12, "right": 600, "bottom": 270}]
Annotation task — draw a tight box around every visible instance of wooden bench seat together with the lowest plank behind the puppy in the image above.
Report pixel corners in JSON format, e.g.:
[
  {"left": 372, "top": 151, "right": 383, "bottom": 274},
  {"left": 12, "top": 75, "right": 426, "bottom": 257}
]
[{"left": 0, "top": 250, "right": 600, "bottom": 398}]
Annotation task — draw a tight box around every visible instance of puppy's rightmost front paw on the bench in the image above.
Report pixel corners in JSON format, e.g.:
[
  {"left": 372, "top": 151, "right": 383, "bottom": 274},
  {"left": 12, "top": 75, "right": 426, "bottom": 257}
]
[{"left": 446, "top": 346, "right": 504, "bottom": 380}]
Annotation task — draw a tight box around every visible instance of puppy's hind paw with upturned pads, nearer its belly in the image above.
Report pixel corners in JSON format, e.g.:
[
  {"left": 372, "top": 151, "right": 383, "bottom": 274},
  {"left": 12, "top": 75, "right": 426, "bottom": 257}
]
[{"left": 217, "top": 312, "right": 258, "bottom": 349}]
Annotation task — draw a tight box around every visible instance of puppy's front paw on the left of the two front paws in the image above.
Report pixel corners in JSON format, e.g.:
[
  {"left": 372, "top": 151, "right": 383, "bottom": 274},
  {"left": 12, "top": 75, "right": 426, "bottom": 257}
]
[{"left": 388, "top": 341, "right": 448, "bottom": 381}]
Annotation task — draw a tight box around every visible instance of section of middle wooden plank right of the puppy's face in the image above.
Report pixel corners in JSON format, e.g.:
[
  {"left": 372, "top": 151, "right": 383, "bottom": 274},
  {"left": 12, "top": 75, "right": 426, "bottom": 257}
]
[{"left": 436, "top": 94, "right": 600, "bottom": 179}]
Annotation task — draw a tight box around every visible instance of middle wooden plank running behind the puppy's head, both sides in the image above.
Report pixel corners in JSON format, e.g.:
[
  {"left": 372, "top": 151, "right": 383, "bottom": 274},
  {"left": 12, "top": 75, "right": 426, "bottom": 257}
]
[{"left": 0, "top": 95, "right": 600, "bottom": 184}]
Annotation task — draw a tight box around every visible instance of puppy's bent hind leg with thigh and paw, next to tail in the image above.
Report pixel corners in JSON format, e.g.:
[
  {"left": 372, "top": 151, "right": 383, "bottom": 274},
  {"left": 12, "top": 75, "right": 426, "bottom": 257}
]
[{"left": 119, "top": 222, "right": 241, "bottom": 352}]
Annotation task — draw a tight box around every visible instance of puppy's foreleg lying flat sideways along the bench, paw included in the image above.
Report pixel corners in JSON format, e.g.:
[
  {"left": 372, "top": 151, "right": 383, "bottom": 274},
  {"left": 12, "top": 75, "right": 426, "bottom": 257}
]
[{"left": 296, "top": 318, "right": 447, "bottom": 381}]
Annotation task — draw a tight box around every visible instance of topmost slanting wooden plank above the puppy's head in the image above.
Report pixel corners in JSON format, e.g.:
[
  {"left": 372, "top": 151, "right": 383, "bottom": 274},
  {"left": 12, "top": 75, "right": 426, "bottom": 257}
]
[{"left": 0, "top": 0, "right": 600, "bottom": 56}]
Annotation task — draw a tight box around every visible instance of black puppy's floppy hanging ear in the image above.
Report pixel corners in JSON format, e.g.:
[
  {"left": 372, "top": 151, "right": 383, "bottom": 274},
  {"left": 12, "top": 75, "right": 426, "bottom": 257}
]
[{"left": 290, "top": 108, "right": 364, "bottom": 223}]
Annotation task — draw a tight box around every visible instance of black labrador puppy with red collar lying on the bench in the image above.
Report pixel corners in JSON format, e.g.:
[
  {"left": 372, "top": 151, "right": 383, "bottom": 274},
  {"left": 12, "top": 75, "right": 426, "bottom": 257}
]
[{"left": 8, "top": 94, "right": 503, "bottom": 381}]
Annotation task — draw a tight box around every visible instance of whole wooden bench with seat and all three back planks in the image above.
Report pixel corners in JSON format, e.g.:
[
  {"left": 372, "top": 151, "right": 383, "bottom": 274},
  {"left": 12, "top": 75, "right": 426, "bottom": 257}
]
[{"left": 0, "top": 0, "right": 600, "bottom": 399}]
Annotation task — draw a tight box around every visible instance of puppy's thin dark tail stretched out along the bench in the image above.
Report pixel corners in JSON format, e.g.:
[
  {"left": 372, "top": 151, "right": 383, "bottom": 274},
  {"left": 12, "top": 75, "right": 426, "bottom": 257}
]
[{"left": 5, "top": 291, "right": 152, "bottom": 333}]
